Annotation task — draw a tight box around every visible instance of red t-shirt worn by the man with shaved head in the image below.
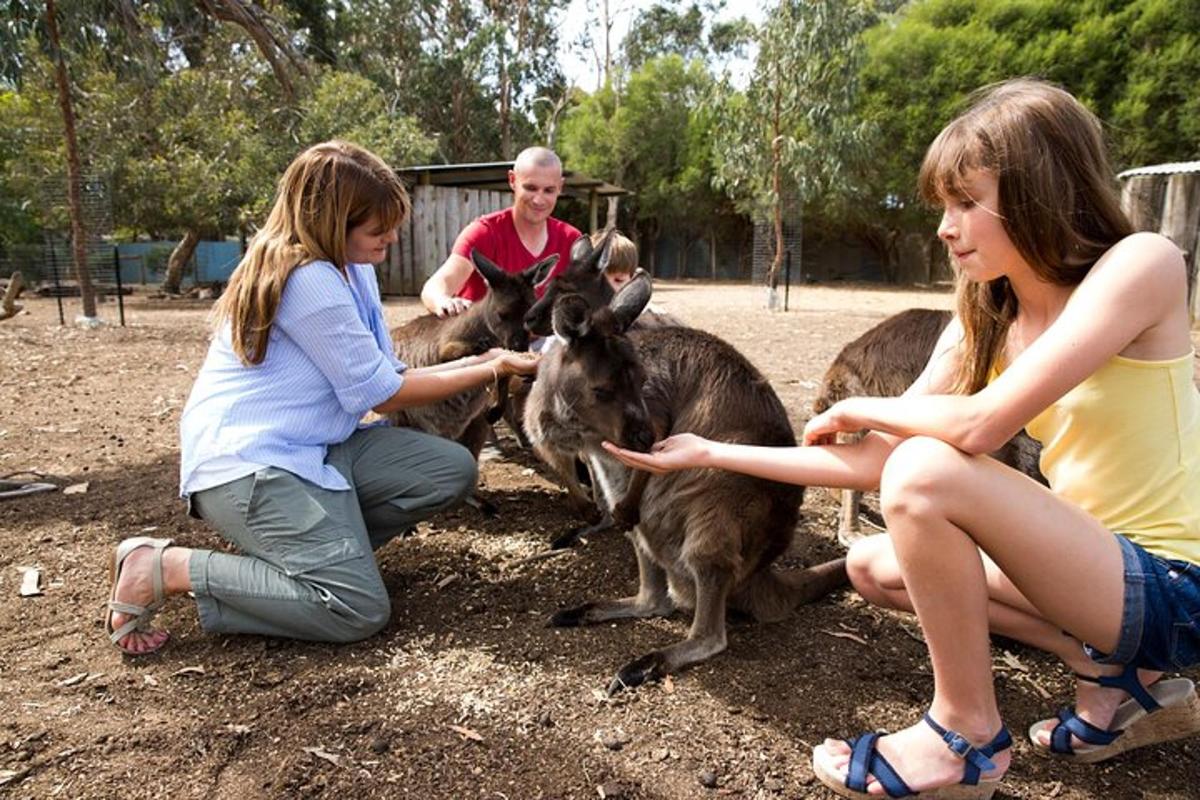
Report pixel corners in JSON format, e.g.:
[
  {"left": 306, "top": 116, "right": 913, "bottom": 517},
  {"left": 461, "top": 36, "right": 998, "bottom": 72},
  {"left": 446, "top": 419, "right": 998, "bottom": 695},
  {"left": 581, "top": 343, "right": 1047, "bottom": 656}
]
[{"left": 452, "top": 207, "right": 582, "bottom": 302}]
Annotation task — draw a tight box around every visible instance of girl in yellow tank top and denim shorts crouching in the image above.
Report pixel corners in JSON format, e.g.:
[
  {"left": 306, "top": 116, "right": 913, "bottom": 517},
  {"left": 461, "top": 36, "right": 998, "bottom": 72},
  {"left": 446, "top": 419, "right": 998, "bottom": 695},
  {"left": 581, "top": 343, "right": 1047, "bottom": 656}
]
[{"left": 604, "top": 80, "right": 1200, "bottom": 798}]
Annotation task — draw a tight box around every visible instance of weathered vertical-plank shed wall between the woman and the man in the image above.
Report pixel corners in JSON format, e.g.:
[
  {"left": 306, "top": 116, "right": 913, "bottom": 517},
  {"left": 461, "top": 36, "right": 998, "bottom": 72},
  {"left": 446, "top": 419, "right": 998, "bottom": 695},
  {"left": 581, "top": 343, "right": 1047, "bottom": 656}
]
[{"left": 379, "top": 185, "right": 512, "bottom": 295}]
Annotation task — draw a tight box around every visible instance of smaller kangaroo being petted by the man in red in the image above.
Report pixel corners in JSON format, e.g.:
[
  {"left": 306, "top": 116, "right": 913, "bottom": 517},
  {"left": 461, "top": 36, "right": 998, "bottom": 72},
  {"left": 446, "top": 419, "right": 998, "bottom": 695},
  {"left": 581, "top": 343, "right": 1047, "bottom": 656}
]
[{"left": 390, "top": 251, "right": 558, "bottom": 459}]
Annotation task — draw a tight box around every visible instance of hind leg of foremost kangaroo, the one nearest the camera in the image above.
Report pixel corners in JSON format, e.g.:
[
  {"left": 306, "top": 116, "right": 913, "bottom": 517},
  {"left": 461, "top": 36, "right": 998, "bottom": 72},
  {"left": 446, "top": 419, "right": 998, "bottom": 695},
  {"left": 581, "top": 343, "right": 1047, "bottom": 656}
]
[{"left": 608, "top": 556, "right": 734, "bottom": 694}]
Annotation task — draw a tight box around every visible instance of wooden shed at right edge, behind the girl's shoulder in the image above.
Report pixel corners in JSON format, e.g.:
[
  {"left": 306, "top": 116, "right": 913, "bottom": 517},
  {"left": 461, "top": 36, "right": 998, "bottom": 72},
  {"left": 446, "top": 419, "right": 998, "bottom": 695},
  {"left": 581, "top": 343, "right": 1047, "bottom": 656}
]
[{"left": 1117, "top": 161, "right": 1200, "bottom": 320}]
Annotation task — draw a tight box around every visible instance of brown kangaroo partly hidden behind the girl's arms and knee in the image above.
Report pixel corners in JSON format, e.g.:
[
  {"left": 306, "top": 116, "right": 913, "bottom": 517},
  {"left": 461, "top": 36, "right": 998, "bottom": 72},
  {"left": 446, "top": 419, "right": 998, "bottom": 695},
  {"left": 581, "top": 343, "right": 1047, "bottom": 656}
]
[{"left": 812, "top": 308, "right": 1046, "bottom": 547}]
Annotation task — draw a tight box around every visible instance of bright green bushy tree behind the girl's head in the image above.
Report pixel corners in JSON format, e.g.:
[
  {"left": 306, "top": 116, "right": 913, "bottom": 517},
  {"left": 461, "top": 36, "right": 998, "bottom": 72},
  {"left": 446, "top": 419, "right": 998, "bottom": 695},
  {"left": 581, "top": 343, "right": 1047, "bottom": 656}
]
[{"left": 858, "top": 0, "right": 1200, "bottom": 215}]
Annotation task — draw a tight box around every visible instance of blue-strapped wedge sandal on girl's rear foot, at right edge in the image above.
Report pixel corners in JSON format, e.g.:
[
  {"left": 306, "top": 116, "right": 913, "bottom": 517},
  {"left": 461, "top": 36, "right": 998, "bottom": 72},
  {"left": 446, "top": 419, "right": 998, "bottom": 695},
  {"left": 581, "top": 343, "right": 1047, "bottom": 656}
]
[{"left": 1030, "top": 664, "right": 1200, "bottom": 764}]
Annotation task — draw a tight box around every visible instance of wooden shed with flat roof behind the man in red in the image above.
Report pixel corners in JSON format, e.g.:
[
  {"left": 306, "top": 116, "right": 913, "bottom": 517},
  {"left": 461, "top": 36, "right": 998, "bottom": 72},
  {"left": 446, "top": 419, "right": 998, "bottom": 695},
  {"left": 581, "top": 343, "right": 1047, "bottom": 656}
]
[{"left": 379, "top": 161, "right": 629, "bottom": 295}]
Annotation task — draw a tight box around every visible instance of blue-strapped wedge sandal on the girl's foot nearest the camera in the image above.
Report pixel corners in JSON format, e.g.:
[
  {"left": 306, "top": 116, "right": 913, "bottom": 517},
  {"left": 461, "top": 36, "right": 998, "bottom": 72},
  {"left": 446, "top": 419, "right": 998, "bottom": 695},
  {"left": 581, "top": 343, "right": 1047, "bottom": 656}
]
[{"left": 812, "top": 714, "right": 1013, "bottom": 800}]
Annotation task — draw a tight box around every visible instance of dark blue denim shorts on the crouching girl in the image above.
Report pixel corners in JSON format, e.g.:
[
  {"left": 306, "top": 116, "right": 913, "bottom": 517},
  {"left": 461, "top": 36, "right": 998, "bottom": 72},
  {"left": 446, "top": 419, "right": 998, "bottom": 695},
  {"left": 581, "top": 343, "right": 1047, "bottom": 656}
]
[{"left": 1085, "top": 535, "right": 1200, "bottom": 672}]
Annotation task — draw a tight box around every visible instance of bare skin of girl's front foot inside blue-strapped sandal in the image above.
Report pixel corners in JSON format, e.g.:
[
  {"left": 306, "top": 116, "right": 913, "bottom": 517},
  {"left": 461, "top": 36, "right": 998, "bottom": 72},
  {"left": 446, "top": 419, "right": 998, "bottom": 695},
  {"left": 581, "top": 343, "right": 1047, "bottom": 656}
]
[{"left": 821, "top": 717, "right": 1013, "bottom": 796}]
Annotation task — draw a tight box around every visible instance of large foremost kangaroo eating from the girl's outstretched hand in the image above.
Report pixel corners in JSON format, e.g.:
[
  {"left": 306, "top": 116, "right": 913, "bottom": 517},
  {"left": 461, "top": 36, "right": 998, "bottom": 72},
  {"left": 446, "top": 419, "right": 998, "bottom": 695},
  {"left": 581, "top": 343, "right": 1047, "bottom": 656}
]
[{"left": 527, "top": 275, "right": 846, "bottom": 692}]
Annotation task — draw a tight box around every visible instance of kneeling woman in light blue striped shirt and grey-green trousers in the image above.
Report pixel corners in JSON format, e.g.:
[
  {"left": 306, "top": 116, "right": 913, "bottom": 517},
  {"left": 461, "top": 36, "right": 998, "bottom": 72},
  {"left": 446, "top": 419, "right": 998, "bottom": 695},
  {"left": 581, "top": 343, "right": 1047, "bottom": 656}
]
[{"left": 106, "top": 142, "right": 536, "bottom": 655}]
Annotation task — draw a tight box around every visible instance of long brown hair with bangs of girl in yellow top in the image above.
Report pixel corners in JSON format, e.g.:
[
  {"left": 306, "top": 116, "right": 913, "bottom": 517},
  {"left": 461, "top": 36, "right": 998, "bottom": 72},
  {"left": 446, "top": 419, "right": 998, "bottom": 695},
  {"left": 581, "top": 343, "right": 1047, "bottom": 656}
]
[{"left": 919, "top": 78, "right": 1133, "bottom": 393}]
